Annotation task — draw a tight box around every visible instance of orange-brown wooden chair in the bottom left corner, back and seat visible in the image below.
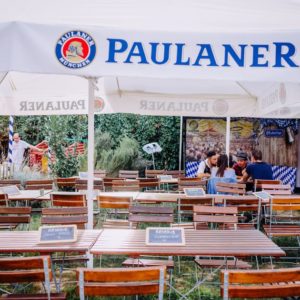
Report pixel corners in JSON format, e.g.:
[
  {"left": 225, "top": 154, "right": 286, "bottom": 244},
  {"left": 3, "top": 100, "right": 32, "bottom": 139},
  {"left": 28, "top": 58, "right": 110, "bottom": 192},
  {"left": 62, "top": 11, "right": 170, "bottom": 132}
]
[{"left": 0, "top": 256, "right": 67, "bottom": 300}]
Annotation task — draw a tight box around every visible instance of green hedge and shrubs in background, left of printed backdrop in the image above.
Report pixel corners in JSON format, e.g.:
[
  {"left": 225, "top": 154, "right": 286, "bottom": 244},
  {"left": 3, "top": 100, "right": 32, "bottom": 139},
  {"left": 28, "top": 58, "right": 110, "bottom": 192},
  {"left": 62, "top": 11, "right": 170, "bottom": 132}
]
[{"left": 4, "top": 114, "right": 180, "bottom": 176}]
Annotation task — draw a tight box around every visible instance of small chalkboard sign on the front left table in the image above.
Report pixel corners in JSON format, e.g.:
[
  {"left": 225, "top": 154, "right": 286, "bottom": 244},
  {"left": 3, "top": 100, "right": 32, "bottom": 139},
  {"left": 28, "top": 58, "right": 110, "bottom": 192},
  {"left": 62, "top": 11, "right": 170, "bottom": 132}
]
[{"left": 39, "top": 225, "right": 77, "bottom": 244}]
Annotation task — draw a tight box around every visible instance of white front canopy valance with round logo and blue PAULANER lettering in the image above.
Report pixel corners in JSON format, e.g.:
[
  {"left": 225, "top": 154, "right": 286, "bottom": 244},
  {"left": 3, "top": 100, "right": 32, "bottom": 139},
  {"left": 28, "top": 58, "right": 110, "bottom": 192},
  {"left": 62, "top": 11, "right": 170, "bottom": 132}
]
[{"left": 0, "top": 22, "right": 300, "bottom": 82}]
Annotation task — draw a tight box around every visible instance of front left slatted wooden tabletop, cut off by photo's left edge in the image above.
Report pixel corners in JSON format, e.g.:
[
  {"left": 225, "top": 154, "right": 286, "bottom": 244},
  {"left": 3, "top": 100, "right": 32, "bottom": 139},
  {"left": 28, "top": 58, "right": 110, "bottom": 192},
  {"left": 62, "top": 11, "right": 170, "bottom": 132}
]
[{"left": 0, "top": 230, "right": 101, "bottom": 253}]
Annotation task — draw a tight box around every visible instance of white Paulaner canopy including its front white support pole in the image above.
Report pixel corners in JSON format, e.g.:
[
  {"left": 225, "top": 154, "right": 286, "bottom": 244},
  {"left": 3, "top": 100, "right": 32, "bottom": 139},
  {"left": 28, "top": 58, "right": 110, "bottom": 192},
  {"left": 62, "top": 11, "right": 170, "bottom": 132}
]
[{"left": 0, "top": 0, "right": 300, "bottom": 228}]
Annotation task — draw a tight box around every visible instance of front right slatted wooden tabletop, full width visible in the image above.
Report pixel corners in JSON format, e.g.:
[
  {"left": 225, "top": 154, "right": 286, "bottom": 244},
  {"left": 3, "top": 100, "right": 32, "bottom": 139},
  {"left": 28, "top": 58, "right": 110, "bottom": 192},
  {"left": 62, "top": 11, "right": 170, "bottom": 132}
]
[{"left": 91, "top": 229, "right": 285, "bottom": 257}]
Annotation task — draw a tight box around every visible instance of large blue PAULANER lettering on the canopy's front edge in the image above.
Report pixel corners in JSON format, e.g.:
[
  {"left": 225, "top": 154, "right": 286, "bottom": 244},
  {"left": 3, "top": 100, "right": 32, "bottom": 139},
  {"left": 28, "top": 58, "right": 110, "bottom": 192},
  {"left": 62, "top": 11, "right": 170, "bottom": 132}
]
[{"left": 106, "top": 38, "right": 299, "bottom": 68}]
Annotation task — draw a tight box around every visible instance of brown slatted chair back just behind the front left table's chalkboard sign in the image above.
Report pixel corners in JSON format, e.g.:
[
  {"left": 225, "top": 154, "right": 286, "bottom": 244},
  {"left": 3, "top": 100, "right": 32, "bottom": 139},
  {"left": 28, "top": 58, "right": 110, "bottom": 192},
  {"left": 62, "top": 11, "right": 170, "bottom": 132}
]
[{"left": 41, "top": 207, "right": 88, "bottom": 229}]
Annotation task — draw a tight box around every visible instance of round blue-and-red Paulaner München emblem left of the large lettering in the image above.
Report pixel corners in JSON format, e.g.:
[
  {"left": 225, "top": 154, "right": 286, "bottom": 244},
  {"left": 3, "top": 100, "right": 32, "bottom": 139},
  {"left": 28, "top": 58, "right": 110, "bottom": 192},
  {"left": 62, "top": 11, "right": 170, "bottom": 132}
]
[{"left": 55, "top": 30, "right": 96, "bottom": 69}]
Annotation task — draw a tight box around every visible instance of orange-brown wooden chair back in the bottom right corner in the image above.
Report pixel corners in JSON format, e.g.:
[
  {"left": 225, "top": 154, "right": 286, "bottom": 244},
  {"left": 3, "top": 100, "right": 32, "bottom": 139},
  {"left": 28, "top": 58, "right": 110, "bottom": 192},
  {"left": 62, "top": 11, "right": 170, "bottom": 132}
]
[{"left": 220, "top": 268, "right": 300, "bottom": 300}]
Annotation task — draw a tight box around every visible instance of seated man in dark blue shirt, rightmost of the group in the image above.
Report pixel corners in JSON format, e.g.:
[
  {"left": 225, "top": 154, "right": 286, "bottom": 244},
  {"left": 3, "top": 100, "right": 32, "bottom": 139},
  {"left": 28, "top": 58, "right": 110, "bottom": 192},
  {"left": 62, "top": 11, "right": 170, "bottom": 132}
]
[{"left": 241, "top": 150, "right": 273, "bottom": 189}]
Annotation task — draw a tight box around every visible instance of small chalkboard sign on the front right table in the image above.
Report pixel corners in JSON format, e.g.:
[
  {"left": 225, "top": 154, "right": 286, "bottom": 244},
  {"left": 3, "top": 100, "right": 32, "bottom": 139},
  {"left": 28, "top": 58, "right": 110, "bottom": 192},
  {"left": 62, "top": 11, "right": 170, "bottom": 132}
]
[{"left": 146, "top": 227, "right": 185, "bottom": 246}]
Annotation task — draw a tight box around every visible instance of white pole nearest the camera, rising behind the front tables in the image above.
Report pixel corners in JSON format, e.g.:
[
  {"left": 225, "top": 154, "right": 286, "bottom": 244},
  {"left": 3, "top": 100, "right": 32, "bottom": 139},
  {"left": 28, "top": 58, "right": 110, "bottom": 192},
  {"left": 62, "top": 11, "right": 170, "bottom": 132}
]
[{"left": 87, "top": 78, "right": 96, "bottom": 229}]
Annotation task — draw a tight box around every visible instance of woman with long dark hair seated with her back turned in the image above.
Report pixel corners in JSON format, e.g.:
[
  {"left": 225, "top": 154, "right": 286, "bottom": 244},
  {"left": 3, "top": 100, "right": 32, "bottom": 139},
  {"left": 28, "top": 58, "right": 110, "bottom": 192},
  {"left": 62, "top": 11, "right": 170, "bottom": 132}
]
[{"left": 207, "top": 154, "right": 236, "bottom": 194}]
